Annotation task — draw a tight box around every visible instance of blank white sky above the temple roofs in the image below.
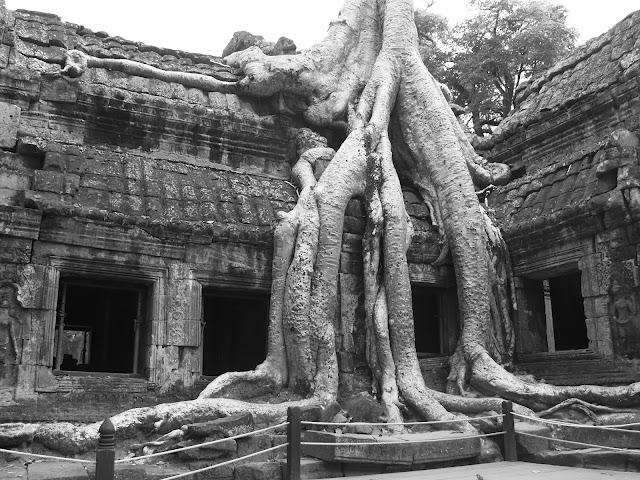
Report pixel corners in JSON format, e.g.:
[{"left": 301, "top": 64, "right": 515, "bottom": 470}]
[{"left": 6, "top": 0, "right": 640, "bottom": 55}]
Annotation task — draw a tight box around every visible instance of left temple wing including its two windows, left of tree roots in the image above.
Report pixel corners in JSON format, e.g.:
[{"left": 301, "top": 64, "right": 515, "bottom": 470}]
[{"left": 0, "top": 5, "right": 295, "bottom": 397}]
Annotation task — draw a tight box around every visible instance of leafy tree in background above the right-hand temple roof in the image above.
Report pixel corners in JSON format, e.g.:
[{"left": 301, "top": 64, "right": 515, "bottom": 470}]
[{"left": 416, "top": 0, "right": 576, "bottom": 135}]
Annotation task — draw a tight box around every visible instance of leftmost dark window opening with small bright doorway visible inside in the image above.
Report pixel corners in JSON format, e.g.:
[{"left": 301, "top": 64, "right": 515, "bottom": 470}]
[{"left": 53, "top": 278, "right": 146, "bottom": 373}]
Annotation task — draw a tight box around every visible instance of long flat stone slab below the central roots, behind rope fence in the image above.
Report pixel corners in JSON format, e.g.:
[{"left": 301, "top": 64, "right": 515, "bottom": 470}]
[{"left": 302, "top": 430, "right": 480, "bottom": 465}]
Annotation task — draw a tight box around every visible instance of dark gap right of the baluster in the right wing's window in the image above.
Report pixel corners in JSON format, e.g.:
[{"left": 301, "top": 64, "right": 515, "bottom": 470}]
[{"left": 549, "top": 272, "right": 589, "bottom": 350}]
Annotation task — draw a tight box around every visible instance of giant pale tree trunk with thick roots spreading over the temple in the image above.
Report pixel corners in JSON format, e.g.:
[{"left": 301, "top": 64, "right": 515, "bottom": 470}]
[{"left": 12, "top": 0, "right": 640, "bottom": 450}]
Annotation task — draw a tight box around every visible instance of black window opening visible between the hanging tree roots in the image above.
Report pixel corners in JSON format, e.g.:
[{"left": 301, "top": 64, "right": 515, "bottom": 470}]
[{"left": 411, "top": 286, "right": 446, "bottom": 355}]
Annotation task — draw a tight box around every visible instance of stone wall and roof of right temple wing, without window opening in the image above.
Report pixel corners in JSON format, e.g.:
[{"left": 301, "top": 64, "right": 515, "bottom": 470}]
[{"left": 488, "top": 12, "right": 640, "bottom": 381}]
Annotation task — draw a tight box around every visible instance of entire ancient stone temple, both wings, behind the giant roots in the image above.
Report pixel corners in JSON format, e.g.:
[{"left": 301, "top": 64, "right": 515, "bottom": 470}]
[{"left": 0, "top": 0, "right": 640, "bottom": 399}]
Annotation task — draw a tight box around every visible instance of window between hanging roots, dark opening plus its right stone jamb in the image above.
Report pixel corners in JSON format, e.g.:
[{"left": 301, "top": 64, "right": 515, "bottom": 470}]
[{"left": 411, "top": 285, "right": 457, "bottom": 356}]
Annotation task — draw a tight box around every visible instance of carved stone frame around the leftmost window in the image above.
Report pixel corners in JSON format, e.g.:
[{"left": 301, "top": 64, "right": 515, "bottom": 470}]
[{"left": 36, "top": 256, "right": 168, "bottom": 391}]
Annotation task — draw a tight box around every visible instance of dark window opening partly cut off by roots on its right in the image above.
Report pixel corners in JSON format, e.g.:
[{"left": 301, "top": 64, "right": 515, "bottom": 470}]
[{"left": 202, "top": 292, "right": 269, "bottom": 376}]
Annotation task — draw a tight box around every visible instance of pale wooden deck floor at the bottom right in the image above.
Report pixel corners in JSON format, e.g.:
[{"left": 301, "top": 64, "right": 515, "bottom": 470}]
[{"left": 350, "top": 462, "right": 640, "bottom": 480}]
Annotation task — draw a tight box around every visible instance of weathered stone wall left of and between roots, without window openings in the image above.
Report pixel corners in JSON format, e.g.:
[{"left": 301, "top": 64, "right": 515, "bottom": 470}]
[{"left": 0, "top": 6, "right": 453, "bottom": 398}]
